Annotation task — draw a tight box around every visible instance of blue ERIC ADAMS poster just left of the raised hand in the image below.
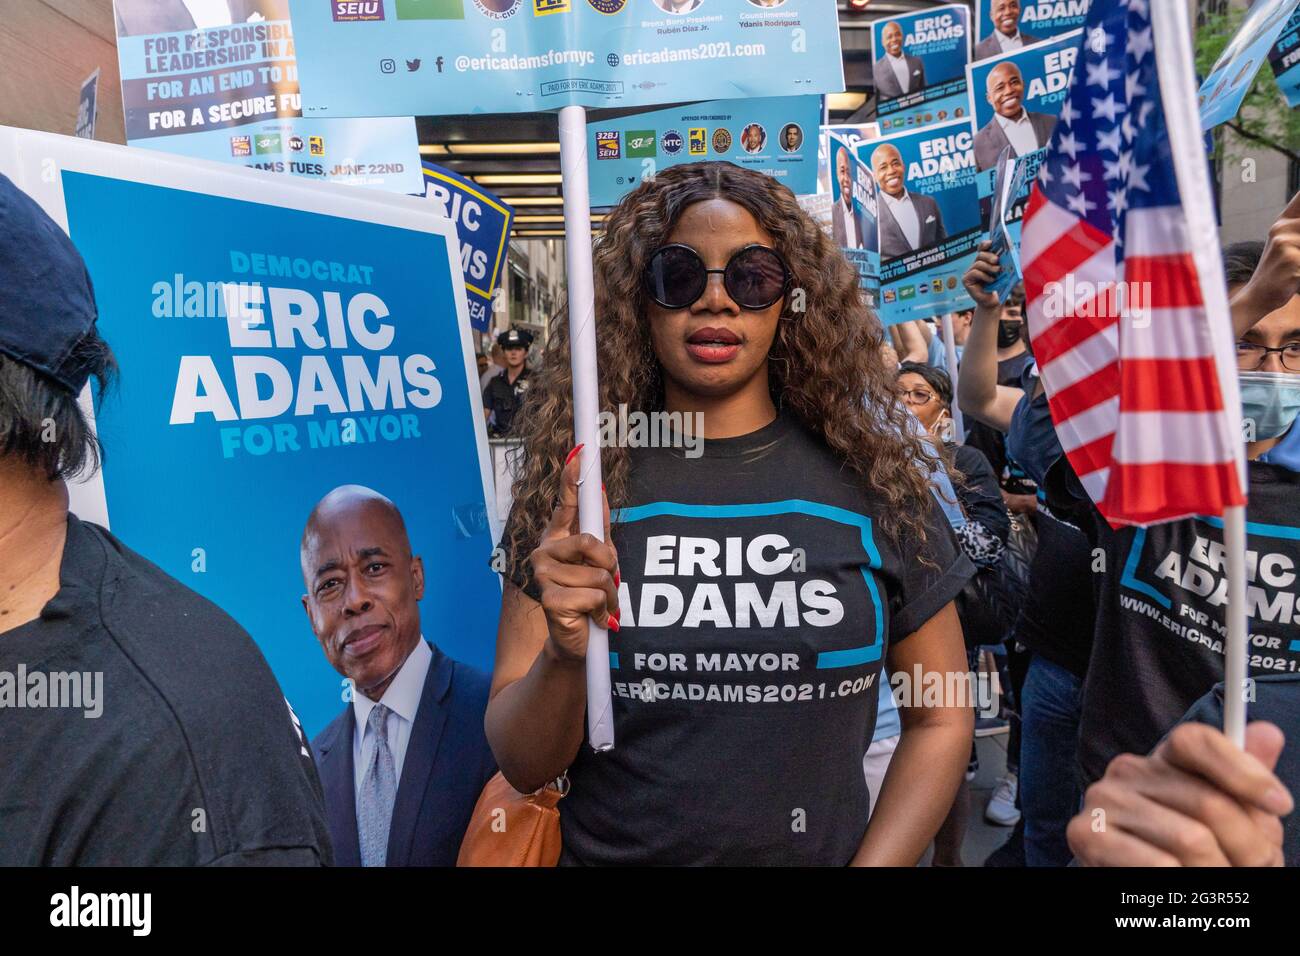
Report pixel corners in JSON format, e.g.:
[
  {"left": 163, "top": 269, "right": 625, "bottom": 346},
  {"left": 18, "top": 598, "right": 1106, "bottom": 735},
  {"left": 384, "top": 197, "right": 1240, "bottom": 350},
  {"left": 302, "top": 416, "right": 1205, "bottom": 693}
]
[{"left": 858, "top": 120, "right": 984, "bottom": 325}]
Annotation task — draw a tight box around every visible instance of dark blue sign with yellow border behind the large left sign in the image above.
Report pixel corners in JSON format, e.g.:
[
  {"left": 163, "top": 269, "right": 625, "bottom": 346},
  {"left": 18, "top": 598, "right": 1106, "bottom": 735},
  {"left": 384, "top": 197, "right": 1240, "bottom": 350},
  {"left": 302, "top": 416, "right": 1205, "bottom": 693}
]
[{"left": 424, "top": 161, "right": 515, "bottom": 332}]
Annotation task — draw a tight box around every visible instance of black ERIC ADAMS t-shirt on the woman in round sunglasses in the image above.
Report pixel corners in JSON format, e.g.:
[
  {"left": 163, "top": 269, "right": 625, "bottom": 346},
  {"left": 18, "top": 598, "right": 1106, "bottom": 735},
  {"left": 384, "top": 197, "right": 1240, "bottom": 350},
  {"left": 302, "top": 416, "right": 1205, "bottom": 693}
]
[{"left": 501, "top": 416, "right": 974, "bottom": 865}]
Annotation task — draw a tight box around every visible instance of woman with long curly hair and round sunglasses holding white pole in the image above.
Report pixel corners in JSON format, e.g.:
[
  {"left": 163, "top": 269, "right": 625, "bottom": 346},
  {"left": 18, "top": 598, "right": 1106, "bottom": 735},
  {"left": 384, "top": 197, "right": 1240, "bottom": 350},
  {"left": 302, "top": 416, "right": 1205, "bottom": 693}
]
[{"left": 486, "top": 163, "right": 972, "bottom": 866}]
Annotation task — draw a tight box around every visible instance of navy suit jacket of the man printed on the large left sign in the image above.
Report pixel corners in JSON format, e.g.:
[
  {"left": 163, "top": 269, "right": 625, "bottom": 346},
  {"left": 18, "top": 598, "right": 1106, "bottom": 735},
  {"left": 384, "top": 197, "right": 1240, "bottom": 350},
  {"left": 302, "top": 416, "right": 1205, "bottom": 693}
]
[{"left": 312, "top": 645, "right": 497, "bottom": 866}]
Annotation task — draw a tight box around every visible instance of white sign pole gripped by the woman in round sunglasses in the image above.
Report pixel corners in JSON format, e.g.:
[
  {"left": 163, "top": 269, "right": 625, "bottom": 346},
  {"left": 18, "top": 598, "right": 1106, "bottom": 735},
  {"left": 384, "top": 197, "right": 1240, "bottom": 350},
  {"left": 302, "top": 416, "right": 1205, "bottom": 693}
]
[{"left": 559, "top": 107, "right": 614, "bottom": 752}]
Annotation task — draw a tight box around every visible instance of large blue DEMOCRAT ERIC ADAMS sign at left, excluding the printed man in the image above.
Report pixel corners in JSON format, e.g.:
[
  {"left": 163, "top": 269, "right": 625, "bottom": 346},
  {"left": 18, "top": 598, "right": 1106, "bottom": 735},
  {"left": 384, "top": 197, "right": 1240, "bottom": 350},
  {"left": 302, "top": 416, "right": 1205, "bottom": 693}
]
[{"left": 0, "top": 127, "right": 501, "bottom": 735}]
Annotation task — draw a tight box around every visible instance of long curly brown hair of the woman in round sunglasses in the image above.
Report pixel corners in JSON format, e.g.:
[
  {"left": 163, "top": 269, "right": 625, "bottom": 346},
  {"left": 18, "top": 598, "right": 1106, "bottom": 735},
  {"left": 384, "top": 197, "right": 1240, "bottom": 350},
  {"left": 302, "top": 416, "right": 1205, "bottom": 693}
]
[{"left": 502, "top": 163, "right": 933, "bottom": 581}]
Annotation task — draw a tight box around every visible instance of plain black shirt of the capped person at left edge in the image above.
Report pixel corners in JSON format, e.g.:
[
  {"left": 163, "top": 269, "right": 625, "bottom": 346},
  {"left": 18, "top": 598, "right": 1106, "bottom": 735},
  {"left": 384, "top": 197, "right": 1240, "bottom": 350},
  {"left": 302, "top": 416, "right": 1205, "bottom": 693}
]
[{"left": 0, "top": 516, "right": 333, "bottom": 866}]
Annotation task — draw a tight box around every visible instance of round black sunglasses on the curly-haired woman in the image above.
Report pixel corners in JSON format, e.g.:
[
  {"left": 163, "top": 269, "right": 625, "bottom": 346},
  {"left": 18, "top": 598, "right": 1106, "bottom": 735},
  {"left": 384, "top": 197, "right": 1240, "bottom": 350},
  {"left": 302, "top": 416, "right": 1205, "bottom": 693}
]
[{"left": 645, "top": 242, "right": 790, "bottom": 312}]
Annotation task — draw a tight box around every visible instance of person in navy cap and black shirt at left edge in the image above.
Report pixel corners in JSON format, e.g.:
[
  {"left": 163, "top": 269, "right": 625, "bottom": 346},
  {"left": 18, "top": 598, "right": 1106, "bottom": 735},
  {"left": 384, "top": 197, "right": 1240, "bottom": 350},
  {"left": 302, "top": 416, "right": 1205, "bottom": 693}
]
[{"left": 0, "top": 176, "right": 333, "bottom": 866}]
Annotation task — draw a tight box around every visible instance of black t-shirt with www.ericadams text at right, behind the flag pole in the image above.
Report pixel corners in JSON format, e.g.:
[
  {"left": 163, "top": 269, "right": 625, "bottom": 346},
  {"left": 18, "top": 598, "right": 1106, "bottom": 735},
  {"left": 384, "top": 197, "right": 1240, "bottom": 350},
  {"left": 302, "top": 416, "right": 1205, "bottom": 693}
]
[{"left": 1079, "top": 462, "right": 1300, "bottom": 782}]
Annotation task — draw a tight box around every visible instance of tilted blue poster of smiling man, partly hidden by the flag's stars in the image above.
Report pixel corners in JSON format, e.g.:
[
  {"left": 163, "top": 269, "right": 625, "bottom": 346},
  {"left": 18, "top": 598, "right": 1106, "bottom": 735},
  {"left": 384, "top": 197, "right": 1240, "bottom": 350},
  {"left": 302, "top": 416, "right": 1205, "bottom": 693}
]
[{"left": 966, "top": 30, "right": 1076, "bottom": 247}]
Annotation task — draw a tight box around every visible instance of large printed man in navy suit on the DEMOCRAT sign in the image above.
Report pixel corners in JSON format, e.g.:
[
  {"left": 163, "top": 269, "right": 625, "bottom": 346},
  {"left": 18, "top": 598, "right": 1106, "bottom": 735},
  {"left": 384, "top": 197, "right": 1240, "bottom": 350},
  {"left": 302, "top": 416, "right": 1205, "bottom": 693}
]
[{"left": 300, "top": 485, "right": 497, "bottom": 866}]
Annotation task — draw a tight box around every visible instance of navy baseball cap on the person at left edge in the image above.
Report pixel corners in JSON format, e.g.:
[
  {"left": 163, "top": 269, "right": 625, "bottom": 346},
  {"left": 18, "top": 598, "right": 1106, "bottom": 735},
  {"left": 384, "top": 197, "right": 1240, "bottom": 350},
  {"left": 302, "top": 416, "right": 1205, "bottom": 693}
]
[{"left": 0, "top": 173, "right": 99, "bottom": 394}]
